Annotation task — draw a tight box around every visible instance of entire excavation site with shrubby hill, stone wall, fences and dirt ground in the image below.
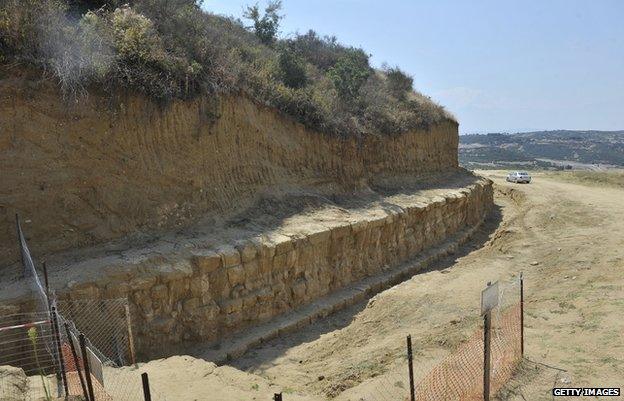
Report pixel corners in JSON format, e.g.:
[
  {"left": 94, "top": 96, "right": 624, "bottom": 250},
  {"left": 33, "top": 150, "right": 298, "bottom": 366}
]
[{"left": 0, "top": 0, "right": 624, "bottom": 401}]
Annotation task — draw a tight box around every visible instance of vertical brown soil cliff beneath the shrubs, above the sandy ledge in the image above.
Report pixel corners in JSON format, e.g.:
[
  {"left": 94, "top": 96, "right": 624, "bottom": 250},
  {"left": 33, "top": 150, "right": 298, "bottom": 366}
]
[{"left": 0, "top": 67, "right": 458, "bottom": 266}]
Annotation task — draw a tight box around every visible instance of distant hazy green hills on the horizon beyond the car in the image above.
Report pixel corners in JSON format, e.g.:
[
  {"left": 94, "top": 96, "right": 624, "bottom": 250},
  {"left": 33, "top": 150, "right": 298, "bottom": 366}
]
[{"left": 459, "top": 130, "right": 624, "bottom": 170}]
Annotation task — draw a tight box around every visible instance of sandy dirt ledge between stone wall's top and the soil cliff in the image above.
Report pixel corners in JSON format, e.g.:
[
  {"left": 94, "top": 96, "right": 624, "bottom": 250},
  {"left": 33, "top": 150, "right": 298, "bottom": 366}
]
[{"left": 0, "top": 169, "right": 479, "bottom": 300}]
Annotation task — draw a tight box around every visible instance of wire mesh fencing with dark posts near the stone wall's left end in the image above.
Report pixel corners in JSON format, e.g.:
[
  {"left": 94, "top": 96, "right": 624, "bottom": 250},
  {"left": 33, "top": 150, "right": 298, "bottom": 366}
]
[{"left": 0, "top": 219, "right": 166, "bottom": 401}]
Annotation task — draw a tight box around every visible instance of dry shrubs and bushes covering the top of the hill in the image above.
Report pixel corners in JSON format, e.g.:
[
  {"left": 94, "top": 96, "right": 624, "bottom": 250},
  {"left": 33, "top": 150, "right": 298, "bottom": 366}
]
[{"left": 0, "top": 0, "right": 451, "bottom": 136}]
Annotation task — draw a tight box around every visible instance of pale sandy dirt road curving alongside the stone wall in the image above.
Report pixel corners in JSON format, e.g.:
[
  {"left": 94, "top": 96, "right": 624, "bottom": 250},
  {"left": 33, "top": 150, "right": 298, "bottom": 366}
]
[{"left": 139, "top": 172, "right": 624, "bottom": 401}]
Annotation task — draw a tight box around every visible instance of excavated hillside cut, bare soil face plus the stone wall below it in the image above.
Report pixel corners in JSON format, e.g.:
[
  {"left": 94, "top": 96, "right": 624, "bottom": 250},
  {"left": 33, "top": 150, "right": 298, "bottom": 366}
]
[{"left": 0, "top": 66, "right": 493, "bottom": 360}]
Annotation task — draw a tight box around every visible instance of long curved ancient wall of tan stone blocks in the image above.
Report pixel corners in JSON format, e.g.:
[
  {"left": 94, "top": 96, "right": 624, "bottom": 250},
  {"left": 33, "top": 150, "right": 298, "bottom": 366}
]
[{"left": 44, "top": 180, "right": 492, "bottom": 357}]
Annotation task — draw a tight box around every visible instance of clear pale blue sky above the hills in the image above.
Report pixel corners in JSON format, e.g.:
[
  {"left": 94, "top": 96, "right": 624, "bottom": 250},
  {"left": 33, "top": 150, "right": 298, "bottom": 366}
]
[{"left": 203, "top": 0, "right": 624, "bottom": 134}]
